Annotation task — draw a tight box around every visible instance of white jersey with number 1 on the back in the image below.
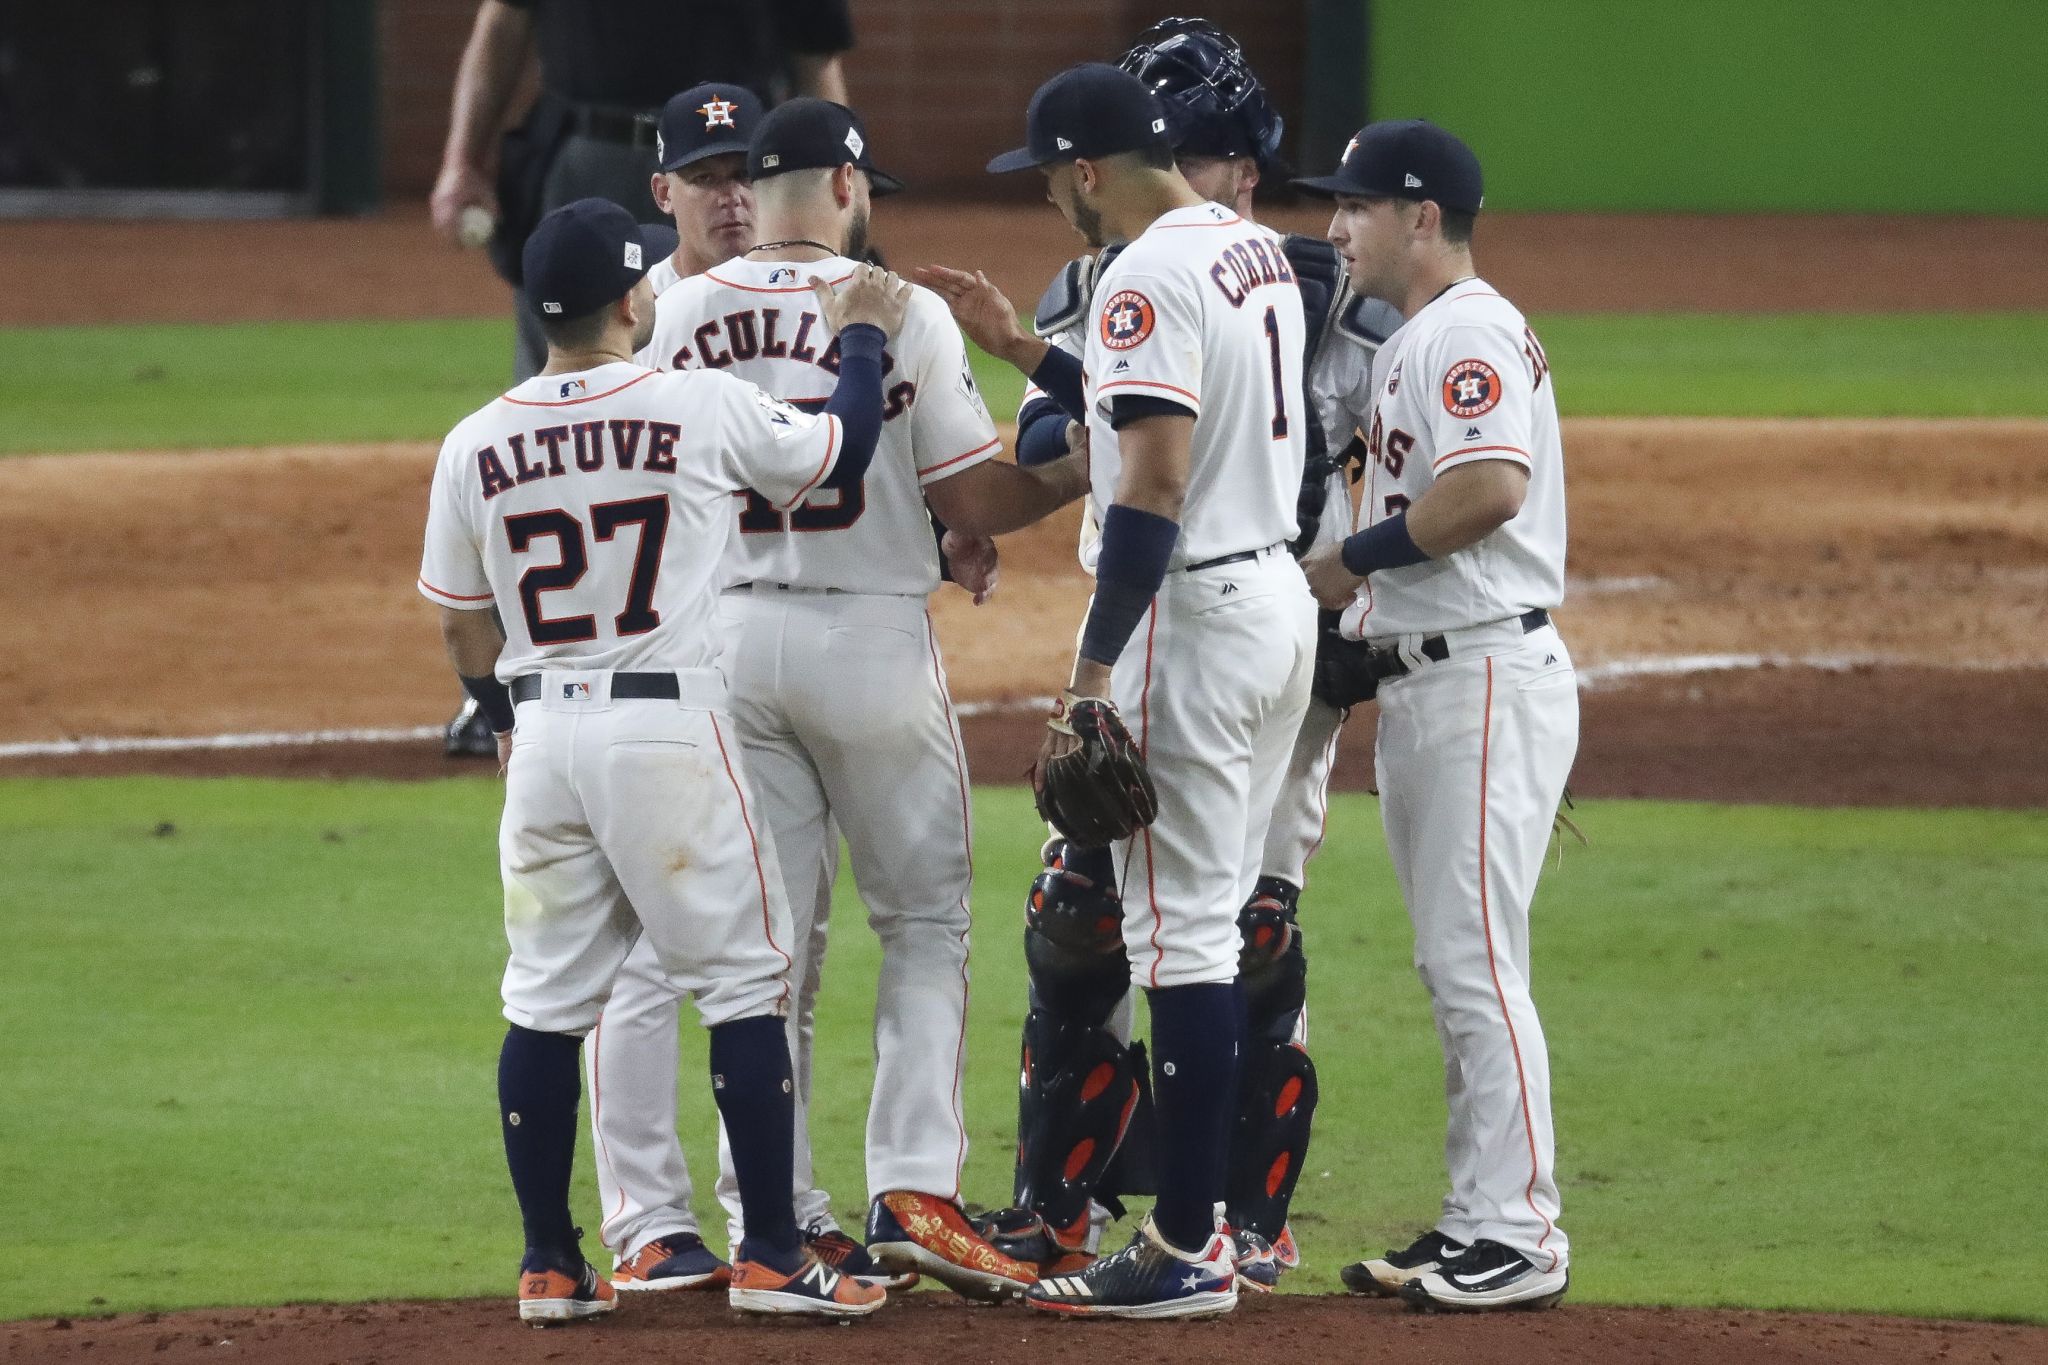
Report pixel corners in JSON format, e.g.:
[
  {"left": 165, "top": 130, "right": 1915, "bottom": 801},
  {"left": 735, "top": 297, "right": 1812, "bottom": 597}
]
[{"left": 1083, "top": 205, "right": 1305, "bottom": 569}]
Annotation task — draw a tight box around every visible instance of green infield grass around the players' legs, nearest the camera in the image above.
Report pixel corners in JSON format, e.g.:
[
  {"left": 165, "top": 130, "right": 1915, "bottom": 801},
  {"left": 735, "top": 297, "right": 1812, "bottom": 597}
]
[{"left": 0, "top": 778, "right": 2048, "bottom": 1318}]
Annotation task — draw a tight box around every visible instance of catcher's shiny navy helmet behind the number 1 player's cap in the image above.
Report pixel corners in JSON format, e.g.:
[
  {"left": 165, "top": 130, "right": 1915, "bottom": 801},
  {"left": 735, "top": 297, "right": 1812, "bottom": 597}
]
[{"left": 1118, "top": 18, "right": 1286, "bottom": 170}]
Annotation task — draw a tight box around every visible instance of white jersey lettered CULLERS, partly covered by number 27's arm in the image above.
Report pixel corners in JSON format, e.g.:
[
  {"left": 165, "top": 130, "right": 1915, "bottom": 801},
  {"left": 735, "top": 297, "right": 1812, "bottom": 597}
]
[{"left": 649, "top": 256, "right": 1001, "bottom": 598}]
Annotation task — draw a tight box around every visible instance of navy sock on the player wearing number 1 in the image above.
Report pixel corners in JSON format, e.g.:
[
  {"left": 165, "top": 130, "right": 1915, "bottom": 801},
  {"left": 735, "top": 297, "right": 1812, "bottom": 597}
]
[{"left": 1147, "top": 982, "right": 1243, "bottom": 1250}]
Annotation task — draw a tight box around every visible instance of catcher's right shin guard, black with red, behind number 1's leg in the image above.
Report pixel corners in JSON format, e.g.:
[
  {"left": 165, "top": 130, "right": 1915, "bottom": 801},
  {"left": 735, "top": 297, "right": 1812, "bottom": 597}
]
[{"left": 1225, "top": 878, "right": 1319, "bottom": 1240}]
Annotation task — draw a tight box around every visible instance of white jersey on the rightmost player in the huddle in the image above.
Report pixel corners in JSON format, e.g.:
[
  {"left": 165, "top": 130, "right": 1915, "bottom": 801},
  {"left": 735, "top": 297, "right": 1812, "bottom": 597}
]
[{"left": 1343, "top": 278, "right": 1565, "bottom": 639}]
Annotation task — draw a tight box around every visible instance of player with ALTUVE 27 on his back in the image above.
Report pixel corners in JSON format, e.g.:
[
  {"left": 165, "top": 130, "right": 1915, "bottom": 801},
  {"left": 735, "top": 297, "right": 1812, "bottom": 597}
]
[{"left": 420, "top": 199, "right": 905, "bottom": 1324}]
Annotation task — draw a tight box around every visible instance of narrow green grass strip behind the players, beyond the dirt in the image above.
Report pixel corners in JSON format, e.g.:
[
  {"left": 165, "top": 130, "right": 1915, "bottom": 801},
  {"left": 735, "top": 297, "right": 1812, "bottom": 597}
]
[{"left": 0, "top": 313, "right": 2048, "bottom": 454}]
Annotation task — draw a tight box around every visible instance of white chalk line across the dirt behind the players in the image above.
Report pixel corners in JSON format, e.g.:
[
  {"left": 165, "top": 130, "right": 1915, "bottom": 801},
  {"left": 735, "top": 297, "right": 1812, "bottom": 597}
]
[{"left": 0, "top": 655, "right": 2048, "bottom": 759}]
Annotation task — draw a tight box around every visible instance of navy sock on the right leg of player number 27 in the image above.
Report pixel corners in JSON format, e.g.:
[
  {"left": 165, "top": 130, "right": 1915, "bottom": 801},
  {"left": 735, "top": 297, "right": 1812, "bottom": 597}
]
[{"left": 711, "top": 1015, "right": 803, "bottom": 1273}]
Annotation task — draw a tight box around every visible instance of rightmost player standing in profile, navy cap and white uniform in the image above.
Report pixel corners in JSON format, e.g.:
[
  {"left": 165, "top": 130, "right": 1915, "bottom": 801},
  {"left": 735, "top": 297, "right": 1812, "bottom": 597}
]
[{"left": 1296, "top": 121, "right": 1579, "bottom": 1310}]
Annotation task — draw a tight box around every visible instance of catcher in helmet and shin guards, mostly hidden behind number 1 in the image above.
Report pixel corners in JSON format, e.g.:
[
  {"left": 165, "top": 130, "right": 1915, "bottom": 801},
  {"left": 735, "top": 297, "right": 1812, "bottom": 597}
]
[{"left": 921, "top": 18, "right": 1401, "bottom": 1289}]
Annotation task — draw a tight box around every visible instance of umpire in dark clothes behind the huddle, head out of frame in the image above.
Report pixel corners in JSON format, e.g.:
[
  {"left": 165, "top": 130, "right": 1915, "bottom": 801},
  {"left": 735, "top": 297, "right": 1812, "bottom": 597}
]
[{"left": 432, "top": 0, "right": 854, "bottom": 379}]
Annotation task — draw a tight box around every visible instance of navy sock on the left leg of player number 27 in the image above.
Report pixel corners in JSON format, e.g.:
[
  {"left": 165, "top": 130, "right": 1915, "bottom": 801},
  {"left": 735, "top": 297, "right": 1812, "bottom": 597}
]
[{"left": 498, "top": 1023, "right": 584, "bottom": 1269}]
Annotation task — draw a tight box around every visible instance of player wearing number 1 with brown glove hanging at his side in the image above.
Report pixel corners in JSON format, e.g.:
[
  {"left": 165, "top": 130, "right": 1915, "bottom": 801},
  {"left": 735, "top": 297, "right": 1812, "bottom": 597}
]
[{"left": 942, "top": 63, "right": 1315, "bottom": 1318}]
